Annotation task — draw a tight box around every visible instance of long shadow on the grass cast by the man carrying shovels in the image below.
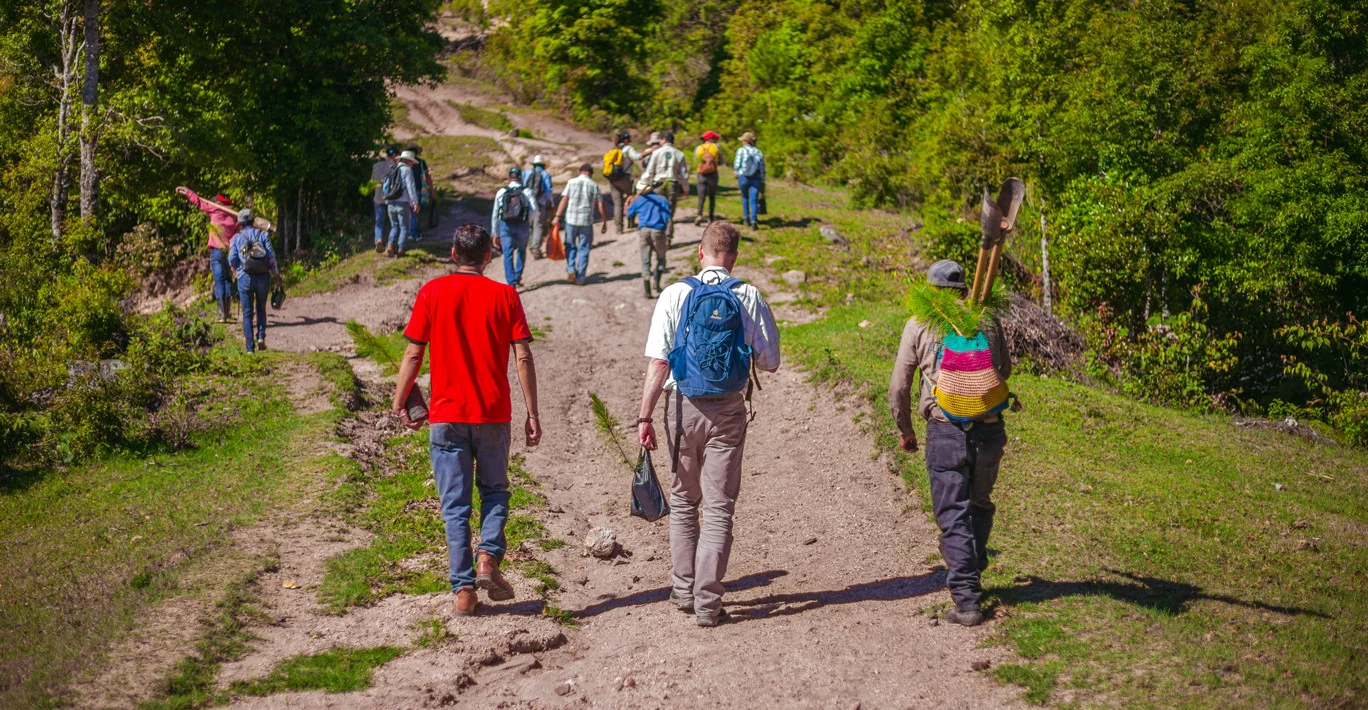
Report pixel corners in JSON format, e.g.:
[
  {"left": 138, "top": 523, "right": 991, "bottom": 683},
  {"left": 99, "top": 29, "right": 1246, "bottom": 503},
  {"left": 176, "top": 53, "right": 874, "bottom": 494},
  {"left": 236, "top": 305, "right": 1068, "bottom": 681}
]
[{"left": 986, "top": 569, "right": 1330, "bottom": 618}]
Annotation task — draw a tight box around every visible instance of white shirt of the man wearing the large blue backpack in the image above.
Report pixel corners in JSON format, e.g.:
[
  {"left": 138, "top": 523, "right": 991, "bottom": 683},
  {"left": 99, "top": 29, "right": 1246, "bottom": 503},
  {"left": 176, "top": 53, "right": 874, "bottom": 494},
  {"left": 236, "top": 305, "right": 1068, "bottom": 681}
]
[{"left": 646, "top": 267, "right": 778, "bottom": 390}]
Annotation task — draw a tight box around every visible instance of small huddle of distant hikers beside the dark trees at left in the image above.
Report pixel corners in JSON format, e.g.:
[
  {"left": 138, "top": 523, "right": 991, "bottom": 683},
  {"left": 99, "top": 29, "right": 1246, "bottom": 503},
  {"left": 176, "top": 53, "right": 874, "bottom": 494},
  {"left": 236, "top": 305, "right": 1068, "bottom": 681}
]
[{"left": 371, "top": 144, "right": 436, "bottom": 256}]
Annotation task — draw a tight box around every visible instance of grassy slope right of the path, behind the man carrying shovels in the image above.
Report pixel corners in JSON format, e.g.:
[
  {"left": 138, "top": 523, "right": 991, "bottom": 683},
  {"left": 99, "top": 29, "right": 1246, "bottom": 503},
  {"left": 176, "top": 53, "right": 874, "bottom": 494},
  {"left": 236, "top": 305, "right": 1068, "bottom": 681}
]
[{"left": 720, "top": 179, "right": 1368, "bottom": 707}]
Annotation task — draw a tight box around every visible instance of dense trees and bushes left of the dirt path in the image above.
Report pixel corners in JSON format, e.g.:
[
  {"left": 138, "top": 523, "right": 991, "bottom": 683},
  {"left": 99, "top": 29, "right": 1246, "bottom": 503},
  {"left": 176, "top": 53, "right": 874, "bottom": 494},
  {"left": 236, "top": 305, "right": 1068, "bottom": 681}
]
[{"left": 0, "top": 0, "right": 442, "bottom": 466}]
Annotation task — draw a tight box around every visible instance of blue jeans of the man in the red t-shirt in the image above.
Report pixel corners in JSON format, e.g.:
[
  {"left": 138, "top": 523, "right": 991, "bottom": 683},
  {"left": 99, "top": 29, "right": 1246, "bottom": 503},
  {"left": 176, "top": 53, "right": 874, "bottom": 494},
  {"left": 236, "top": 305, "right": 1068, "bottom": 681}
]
[{"left": 428, "top": 423, "right": 509, "bottom": 591}]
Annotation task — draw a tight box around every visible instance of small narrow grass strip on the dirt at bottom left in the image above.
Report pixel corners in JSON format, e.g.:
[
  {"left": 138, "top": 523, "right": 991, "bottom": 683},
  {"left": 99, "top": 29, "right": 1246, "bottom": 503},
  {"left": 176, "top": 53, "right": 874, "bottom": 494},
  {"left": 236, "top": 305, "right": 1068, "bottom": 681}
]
[{"left": 230, "top": 646, "right": 404, "bottom": 695}]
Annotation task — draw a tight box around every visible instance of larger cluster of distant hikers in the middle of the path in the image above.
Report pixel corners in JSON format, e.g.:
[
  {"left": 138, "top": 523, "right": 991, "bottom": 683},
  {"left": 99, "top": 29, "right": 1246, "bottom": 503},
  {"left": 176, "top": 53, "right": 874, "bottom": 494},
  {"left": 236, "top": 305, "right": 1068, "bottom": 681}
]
[{"left": 490, "top": 131, "right": 766, "bottom": 298}]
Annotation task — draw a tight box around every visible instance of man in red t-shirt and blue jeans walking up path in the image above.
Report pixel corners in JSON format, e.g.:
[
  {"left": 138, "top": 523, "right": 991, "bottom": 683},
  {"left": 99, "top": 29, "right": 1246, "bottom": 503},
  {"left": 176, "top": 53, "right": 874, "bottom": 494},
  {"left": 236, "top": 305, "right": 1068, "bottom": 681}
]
[{"left": 393, "top": 224, "right": 542, "bottom": 616}]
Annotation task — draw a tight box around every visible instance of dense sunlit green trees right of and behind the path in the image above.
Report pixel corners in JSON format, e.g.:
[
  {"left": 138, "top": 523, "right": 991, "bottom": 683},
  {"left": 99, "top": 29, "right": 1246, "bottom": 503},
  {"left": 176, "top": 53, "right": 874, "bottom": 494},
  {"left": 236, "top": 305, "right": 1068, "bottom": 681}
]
[{"left": 486, "top": 0, "right": 1368, "bottom": 437}]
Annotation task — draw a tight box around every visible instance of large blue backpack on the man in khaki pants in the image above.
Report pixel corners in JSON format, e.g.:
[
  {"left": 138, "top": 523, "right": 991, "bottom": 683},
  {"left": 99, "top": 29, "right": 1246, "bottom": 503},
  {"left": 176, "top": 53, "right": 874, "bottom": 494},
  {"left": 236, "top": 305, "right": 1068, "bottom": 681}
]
[{"left": 669, "top": 276, "right": 751, "bottom": 398}]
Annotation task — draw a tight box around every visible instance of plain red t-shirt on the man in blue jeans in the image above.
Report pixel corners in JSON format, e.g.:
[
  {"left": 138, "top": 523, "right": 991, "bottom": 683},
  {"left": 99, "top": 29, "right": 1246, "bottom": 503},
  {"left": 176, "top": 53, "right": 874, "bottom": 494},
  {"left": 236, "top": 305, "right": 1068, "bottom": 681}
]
[{"left": 404, "top": 274, "right": 532, "bottom": 424}]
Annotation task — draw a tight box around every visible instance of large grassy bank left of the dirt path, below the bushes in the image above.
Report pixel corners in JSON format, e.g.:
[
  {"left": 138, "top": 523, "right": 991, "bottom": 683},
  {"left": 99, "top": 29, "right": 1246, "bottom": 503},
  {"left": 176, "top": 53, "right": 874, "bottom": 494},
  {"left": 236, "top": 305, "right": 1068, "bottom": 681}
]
[{"left": 0, "top": 353, "right": 352, "bottom": 706}]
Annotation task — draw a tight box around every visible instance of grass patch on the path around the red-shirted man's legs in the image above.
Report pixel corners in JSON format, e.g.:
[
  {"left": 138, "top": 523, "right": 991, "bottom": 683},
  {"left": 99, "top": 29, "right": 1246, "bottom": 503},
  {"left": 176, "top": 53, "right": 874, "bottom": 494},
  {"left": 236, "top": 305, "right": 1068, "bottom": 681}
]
[{"left": 319, "top": 430, "right": 554, "bottom": 613}]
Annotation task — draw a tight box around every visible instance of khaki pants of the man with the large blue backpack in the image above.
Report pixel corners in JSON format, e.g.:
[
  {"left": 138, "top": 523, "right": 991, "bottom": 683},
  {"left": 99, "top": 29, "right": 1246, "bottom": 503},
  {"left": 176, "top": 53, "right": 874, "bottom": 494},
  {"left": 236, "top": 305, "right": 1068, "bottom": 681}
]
[{"left": 665, "top": 391, "right": 747, "bottom": 617}]
